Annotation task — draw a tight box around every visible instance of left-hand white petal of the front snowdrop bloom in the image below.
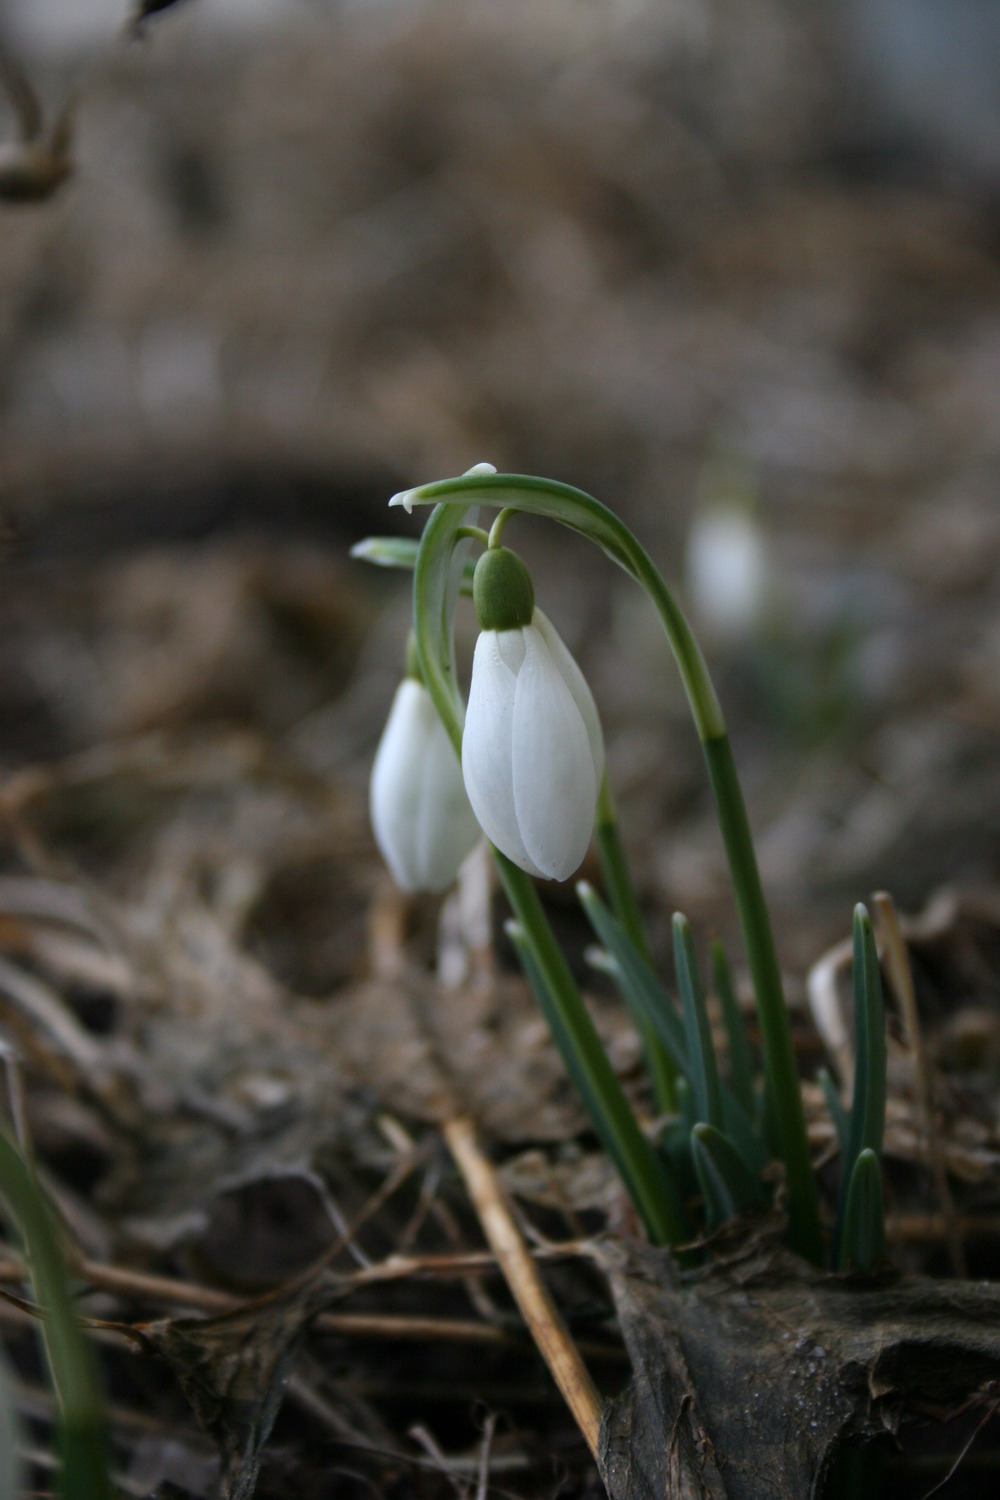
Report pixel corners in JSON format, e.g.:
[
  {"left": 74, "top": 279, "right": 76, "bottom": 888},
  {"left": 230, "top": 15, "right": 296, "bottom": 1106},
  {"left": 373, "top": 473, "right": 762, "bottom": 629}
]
[{"left": 462, "top": 630, "right": 541, "bottom": 875}]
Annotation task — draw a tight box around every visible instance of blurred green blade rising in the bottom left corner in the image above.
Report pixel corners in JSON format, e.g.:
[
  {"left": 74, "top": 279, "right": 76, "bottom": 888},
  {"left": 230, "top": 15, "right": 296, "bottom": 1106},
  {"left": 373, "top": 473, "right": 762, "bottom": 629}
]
[{"left": 0, "top": 1133, "right": 111, "bottom": 1500}]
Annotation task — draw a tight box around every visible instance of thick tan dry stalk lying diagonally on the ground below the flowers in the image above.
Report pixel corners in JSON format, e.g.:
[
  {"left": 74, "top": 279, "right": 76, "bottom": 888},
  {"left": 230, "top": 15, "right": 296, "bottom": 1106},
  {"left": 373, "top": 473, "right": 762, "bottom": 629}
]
[{"left": 442, "top": 1115, "right": 601, "bottom": 1458}]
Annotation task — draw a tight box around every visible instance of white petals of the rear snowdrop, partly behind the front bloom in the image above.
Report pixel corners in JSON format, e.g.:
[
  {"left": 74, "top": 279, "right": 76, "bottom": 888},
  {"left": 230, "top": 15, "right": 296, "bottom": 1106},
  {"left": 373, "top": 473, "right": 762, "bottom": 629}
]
[{"left": 369, "top": 677, "right": 480, "bottom": 891}]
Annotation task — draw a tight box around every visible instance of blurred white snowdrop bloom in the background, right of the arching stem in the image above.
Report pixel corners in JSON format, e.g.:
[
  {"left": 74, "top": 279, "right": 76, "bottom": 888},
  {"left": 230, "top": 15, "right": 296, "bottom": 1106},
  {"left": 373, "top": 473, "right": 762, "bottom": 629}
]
[{"left": 687, "top": 504, "right": 769, "bottom": 641}]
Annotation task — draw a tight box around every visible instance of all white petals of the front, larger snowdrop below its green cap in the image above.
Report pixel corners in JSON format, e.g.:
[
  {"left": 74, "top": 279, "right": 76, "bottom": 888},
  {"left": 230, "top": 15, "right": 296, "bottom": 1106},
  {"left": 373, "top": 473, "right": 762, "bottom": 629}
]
[{"left": 462, "top": 609, "right": 604, "bottom": 881}]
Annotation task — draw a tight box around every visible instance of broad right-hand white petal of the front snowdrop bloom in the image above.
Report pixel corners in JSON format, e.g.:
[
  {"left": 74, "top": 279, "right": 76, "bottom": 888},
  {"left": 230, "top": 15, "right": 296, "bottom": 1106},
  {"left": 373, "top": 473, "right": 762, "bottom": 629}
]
[{"left": 513, "top": 626, "right": 597, "bottom": 881}]
